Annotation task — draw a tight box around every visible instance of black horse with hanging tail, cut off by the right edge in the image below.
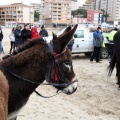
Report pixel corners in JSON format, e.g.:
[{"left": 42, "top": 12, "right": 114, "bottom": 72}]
[{"left": 108, "top": 30, "right": 120, "bottom": 89}]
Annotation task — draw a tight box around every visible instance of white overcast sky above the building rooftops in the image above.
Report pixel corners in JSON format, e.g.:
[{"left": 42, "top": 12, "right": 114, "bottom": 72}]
[{"left": 0, "top": 0, "right": 85, "bottom": 5}]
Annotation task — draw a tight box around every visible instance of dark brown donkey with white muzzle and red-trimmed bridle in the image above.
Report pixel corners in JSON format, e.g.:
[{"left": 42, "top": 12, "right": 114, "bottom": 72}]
[{"left": 0, "top": 24, "right": 78, "bottom": 120}]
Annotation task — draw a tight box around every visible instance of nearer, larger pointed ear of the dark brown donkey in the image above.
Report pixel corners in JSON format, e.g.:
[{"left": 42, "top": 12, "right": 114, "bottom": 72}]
[{"left": 58, "top": 24, "right": 78, "bottom": 53}]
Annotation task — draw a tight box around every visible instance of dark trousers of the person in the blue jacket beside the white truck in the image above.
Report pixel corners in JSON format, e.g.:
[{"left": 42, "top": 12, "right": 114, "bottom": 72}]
[{"left": 90, "top": 47, "right": 101, "bottom": 62}]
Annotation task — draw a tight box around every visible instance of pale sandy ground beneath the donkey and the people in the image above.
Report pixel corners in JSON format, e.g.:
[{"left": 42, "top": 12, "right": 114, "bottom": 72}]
[{"left": 3, "top": 29, "right": 120, "bottom": 120}]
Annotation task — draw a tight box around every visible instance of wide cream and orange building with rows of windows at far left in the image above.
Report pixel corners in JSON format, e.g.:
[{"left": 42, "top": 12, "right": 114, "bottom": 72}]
[{"left": 0, "top": 3, "right": 34, "bottom": 27}]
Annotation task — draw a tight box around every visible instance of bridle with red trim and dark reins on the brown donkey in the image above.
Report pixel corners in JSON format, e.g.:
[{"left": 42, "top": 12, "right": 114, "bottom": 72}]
[{"left": 4, "top": 41, "right": 78, "bottom": 98}]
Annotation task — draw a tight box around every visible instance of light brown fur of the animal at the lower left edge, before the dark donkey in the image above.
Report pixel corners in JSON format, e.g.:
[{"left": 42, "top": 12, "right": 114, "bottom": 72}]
[{"left": 0, "top": 72, "right": 8, "bottom": 120}]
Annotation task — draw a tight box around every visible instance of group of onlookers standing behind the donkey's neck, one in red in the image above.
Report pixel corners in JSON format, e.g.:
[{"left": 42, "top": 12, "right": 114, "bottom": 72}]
[{"left": 0, "top": 24, "right": 48, "bottom": 55}]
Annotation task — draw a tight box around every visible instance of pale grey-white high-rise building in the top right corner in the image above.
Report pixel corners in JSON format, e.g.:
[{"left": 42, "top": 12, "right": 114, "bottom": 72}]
[{"left": 96, "top": 0, "right": 120, "bottom": 22}]
